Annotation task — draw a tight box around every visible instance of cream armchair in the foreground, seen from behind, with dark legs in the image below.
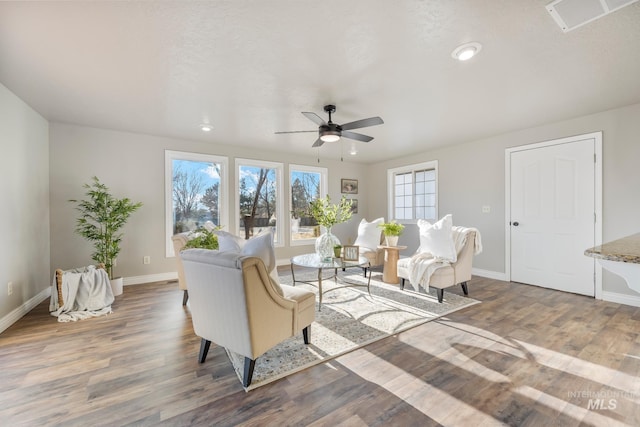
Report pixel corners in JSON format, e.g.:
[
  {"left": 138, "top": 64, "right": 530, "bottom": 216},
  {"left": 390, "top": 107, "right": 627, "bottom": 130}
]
[{"left": 180, "top": 249, "right": 316, "bottom": 387}]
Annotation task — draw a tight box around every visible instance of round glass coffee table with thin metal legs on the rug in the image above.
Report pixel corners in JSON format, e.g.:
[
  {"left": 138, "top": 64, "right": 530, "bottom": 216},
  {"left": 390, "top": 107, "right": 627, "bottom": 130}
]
[{"left": 291, "top": 253, "right": 371, "bottom": 310}]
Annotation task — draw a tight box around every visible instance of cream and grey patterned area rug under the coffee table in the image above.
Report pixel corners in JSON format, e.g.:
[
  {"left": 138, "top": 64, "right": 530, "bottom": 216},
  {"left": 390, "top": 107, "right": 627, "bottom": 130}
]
[{"left": 227, "top": 270, "right": 479, "bottom": 391}]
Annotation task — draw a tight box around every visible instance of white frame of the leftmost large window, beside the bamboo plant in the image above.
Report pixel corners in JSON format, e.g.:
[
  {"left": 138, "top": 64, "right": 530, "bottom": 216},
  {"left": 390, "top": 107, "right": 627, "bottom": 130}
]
[{"left": 164, "top": 150, "right": 229, "bottom": 258}]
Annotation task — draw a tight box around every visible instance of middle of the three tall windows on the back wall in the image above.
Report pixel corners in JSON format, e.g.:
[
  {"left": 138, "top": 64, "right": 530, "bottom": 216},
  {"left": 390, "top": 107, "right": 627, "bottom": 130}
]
[{"left": 236, "top": 159, "right": 283, "bottom": 245}]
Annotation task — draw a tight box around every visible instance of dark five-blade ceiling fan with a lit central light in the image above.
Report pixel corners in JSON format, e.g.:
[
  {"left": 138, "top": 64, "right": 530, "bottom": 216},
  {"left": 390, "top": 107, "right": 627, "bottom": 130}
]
[{"left": 276, "top": 104, "right": 384, "bottom": 147}]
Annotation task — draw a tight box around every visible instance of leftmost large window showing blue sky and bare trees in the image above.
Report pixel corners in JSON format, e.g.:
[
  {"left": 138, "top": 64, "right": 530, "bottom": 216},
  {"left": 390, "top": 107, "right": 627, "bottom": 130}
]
[{"left": 165, "top": 150, "right": 229, "bottom": 257}]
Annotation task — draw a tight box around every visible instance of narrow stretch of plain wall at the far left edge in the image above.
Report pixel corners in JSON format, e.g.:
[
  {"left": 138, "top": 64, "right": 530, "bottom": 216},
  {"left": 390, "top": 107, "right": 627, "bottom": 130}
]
[{"left": 0, "top": 84, "right": 52, "bottom": 320}]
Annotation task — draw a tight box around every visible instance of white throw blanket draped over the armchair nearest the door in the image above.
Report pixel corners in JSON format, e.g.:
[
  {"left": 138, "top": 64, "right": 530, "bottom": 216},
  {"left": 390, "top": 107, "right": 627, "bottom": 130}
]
[{"left": 409, "top": 226, "right": 482, "bottom": 290}]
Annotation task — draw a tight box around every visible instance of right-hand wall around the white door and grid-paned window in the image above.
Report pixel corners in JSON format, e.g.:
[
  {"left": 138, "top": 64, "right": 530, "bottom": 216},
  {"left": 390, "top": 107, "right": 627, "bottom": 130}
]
[{"left": 367, "top": 104, "right": 640, "bottom": 296}]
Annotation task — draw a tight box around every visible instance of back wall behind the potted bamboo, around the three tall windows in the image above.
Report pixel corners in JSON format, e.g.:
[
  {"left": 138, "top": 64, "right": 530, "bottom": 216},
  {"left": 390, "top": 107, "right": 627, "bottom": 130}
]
[{"left": 50, "top": 123, "right": 368, "bottom": 283}]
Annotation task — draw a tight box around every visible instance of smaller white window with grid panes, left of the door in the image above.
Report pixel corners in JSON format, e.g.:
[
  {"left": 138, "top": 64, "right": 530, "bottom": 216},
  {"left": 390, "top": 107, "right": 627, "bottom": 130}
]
[{"left": 387, "top": 160, "right": 438, "bottom": 222}]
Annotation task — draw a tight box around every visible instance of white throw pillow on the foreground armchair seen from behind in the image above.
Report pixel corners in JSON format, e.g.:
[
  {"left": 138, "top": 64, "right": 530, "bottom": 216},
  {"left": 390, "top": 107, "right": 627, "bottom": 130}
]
[{"left": 215, "top": 229, "right": 280, "bottom": 283}]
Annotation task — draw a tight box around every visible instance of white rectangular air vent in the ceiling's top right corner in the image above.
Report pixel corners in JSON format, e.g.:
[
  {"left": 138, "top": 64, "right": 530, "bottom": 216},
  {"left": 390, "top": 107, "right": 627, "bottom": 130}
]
[{"left": 546, "top": 0, "right": 638, "bottom": 33}]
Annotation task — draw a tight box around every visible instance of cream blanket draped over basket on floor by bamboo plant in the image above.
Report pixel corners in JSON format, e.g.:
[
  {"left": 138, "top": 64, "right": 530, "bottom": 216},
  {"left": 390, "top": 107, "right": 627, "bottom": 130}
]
[{"left": 49, "top": 265, "right": 114, "bottom": 322}]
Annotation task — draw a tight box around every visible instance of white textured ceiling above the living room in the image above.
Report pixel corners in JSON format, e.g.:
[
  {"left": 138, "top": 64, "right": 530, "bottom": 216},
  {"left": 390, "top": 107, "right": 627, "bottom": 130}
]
[{"left": 0, "top": 0, "right": 640, "bottom": 163}]
